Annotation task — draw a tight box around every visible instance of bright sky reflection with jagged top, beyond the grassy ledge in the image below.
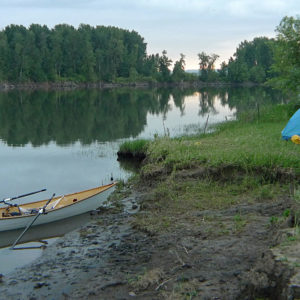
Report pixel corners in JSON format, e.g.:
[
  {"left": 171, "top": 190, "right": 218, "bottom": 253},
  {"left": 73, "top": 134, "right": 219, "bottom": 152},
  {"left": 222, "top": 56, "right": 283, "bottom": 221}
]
[{"left": 138, "top": 93, "right": 235, "bottom": 138}]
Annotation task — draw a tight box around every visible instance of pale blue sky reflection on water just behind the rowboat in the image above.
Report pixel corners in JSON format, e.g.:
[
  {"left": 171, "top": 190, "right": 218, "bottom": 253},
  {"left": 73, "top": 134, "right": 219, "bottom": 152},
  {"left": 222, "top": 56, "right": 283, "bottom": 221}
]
[{"left": 0, "top": 142, "right": 129, "bottom": 202}]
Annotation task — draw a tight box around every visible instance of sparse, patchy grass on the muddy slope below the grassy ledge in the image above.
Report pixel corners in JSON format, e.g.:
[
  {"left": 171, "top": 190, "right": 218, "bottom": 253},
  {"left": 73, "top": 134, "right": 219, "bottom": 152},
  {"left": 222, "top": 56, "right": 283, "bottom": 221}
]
[{"left": 132, "top": 177, "right": 288, "bottom": 234}]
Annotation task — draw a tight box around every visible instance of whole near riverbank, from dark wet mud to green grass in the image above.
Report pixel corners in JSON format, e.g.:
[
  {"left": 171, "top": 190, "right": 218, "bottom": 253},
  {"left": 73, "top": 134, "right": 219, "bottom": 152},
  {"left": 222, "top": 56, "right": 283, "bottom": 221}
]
[{"left": 0, "top": 106, "right": 300, "bottom": 299}]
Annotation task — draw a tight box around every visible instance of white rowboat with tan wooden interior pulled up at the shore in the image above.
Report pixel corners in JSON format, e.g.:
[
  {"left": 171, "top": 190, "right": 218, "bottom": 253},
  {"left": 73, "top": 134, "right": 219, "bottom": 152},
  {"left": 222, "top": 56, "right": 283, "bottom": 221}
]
[{"left": 0, "top": 182, "right": 116, "bottom": 231}]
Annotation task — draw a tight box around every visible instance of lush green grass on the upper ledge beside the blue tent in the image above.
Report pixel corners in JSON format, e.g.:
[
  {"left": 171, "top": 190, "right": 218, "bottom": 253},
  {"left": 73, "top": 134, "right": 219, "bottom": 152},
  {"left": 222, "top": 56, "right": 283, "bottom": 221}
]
[{"left": 143, "top": 106, "right": 300, "bottom": 175}]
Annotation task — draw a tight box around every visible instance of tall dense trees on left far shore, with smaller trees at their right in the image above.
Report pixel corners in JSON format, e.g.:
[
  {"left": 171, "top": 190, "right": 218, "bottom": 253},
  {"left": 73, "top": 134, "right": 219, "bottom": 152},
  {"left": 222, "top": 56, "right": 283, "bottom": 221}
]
[{"left": 0, "top": 24, "right": 195, "bottom": 83}]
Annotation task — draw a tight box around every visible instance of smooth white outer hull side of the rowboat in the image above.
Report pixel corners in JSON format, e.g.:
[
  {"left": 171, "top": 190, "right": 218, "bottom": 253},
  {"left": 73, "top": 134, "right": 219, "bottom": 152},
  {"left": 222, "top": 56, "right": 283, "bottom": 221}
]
[{"left": 0, "top": 186, "right": 114, "bottom": 231}]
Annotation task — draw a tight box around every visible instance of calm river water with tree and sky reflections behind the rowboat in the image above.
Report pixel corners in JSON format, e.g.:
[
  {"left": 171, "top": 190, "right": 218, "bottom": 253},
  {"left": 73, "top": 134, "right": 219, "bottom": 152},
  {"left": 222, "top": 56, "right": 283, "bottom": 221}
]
[{"left": 0, "top": 87, "right": 283, "bottom": 273}]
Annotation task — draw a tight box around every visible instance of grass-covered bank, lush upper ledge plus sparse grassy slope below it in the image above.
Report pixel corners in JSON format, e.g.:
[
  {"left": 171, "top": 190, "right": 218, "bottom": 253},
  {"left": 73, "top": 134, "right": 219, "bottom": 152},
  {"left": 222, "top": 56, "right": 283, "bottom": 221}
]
[{"left": 119, "top": 105, "right": 300, "bottom": 234}]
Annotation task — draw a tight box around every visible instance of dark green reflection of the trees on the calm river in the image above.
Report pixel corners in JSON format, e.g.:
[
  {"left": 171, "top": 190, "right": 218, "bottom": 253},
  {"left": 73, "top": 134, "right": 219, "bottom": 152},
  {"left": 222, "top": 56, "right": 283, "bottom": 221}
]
[{"left": 0, "top": 87, "right": 282, "bottom": 146}]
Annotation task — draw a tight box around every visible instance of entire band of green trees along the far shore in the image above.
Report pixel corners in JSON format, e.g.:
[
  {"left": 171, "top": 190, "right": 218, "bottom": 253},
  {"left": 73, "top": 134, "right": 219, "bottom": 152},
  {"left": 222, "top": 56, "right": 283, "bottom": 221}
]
[{"left": 0, "top": 17, "right": 300, "bottom": 93}]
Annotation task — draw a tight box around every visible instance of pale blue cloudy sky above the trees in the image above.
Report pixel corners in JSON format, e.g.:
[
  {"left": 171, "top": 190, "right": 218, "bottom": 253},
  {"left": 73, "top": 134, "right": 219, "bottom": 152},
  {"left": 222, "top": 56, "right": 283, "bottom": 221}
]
[{"left": 0, "top": 0, "right": 300, "bottom": 69}]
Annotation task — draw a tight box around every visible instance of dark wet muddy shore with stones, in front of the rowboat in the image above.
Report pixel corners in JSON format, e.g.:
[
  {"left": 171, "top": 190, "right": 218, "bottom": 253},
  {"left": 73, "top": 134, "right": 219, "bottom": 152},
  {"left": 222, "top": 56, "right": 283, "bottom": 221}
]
[{"left": 0, "top": 175, "right": 299, "bottom": 300}]
